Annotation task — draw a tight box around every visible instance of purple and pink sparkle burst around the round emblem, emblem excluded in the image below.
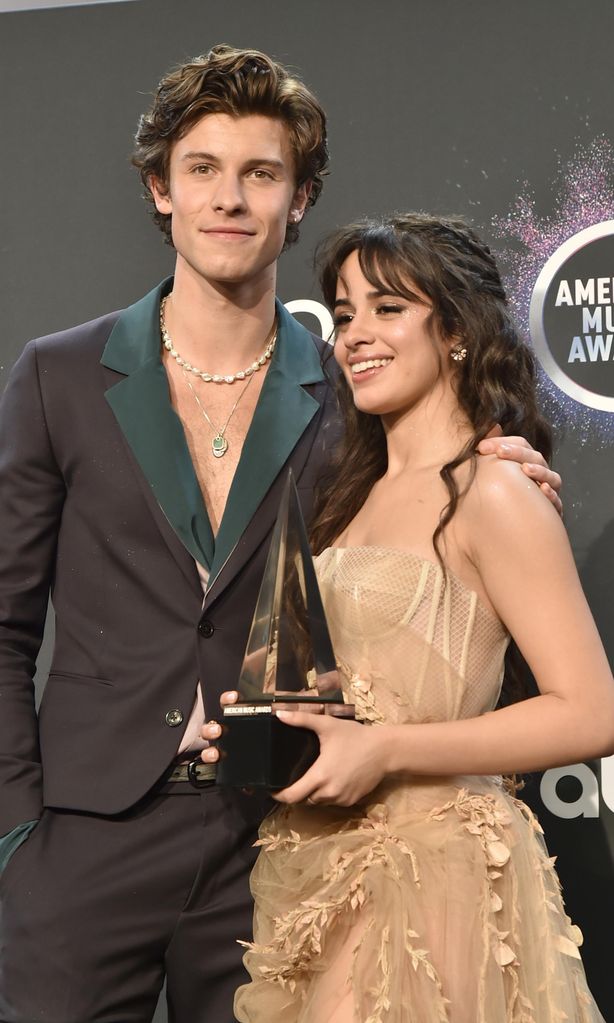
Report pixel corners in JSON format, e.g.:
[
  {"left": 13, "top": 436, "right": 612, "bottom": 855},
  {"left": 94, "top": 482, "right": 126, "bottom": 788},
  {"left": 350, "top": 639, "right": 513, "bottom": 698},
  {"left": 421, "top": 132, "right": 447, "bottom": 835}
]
[{"left": 492, "top": 135, "right": 614, "bottom": 445}]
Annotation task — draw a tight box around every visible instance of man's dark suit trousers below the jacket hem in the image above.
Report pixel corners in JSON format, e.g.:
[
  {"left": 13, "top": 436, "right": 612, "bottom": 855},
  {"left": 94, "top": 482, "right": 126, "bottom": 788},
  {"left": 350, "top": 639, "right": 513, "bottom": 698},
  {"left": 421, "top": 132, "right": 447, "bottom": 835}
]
[{"left": 0, "top": 783, "right": 266, "bottom": 1023}]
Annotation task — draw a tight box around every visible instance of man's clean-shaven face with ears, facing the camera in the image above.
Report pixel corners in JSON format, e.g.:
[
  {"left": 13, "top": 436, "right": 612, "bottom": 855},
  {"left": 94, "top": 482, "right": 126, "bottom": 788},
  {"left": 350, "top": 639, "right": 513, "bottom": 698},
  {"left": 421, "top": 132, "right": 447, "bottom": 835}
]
[{"left": 150, "top": 114, "right": 309, "bottom": 286}]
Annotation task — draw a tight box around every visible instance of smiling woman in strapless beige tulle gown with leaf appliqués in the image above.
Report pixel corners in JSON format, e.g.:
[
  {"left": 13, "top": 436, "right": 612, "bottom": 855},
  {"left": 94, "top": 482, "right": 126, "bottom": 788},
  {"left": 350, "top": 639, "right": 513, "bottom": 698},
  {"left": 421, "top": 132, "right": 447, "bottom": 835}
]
[{"left": 207, "top": 215, "right": 614, "bottom": 1023}]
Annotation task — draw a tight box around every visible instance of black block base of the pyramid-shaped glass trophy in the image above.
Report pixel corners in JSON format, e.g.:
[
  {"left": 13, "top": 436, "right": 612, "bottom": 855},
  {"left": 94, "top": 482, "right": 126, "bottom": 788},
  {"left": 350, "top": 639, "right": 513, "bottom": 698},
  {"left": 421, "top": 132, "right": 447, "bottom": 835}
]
[{"left": 217, "top": 702, "right": 354, "bottom": 792}]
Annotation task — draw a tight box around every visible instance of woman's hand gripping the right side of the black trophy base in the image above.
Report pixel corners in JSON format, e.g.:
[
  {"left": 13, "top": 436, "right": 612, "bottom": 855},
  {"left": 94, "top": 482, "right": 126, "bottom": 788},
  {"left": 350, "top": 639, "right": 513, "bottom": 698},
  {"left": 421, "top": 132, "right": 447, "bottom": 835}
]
[{"left": 273, "top": 711, "right": 388, "bottom": 806}]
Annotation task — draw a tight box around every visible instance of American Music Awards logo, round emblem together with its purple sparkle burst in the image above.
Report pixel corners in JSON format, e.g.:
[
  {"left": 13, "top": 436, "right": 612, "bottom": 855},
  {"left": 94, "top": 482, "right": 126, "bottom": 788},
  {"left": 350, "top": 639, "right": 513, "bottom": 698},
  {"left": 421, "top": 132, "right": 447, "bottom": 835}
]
[{"left": 492, "top": 135, "right": 614, "bottom": 446}]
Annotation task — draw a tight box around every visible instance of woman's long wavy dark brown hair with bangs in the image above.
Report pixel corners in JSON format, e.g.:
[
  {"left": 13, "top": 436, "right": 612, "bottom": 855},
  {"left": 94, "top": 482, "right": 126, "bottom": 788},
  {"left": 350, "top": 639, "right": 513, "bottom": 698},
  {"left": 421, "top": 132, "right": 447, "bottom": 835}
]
[{"left": 311, "top": 213, "right": 552, "bottom": 697}]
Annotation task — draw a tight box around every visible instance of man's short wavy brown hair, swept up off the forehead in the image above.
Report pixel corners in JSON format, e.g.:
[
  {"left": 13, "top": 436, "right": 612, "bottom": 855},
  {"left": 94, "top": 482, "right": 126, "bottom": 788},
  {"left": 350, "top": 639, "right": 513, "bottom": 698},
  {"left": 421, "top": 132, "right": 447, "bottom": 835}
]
[{"left": 132, "top": 45, "right": 328, "bottom": 247}]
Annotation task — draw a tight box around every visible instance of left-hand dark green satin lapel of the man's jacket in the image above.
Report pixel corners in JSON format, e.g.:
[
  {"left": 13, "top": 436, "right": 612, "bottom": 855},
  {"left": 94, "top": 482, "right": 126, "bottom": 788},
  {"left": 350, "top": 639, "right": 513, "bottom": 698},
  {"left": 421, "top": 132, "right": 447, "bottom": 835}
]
[{"left": 100, "top": 281, "right": 214, "bottom": 568}]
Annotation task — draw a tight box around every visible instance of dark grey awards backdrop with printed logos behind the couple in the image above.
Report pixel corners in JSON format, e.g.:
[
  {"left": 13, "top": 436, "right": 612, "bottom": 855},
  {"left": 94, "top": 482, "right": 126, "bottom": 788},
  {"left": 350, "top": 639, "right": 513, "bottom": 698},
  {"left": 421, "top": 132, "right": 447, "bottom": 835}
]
[{"left": 0, "top": 0, "right": 614, "bottom": 1023}]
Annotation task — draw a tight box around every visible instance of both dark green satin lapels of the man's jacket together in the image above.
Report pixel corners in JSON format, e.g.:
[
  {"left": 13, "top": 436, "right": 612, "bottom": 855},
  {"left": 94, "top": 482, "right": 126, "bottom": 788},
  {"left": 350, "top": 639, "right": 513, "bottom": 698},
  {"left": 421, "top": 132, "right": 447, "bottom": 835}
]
[{"left": 100, "top": 279, "right": 323, "bottom": 582}]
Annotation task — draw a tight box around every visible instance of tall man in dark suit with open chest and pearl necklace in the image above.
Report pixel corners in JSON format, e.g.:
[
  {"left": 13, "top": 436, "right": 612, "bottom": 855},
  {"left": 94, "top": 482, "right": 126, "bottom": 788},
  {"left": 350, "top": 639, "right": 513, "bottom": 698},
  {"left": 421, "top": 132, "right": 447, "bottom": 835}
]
[{"left": 0, "top": 46, "right": 557, "bottom": 1023}]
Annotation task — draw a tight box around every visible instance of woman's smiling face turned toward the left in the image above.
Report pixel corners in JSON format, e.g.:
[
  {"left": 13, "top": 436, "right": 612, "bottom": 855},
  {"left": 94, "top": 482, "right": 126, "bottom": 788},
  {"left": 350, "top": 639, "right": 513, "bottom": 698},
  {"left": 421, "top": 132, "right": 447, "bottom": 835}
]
[{"left": 335, "top": 252, "right": 452, "bottom": 415}]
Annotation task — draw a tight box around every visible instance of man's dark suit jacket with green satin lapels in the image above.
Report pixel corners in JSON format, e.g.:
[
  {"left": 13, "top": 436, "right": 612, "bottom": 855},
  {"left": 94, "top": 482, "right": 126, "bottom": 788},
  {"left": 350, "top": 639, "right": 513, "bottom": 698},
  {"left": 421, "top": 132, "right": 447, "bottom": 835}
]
[{"left": 0, "top": 281, "right": 338, "bottom": 835}]
